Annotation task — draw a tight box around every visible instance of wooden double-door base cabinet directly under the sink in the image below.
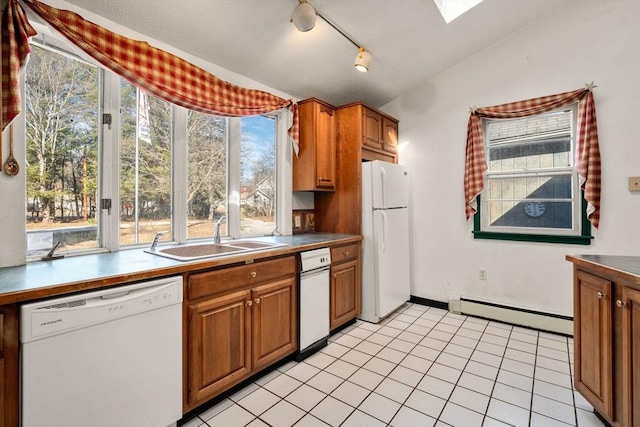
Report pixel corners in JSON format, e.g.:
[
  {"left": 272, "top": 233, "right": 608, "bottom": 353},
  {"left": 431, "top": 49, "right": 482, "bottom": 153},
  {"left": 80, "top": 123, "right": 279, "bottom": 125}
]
[{"left": 185, "top": 256, "right": 298, "bottom": 411}]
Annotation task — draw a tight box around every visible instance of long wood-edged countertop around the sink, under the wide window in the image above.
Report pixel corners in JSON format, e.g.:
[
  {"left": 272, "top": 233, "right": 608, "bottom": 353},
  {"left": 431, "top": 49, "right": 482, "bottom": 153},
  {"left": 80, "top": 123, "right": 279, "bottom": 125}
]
[{"left": 0, "top": 233, "right": 362, "bottom": 305}]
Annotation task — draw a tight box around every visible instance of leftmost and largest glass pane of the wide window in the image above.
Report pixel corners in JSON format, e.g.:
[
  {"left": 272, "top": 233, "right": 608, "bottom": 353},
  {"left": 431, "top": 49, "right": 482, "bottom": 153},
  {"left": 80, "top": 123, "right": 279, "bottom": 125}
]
[{"left": 25, "top": 45, "right": 99, "bottom": 256}]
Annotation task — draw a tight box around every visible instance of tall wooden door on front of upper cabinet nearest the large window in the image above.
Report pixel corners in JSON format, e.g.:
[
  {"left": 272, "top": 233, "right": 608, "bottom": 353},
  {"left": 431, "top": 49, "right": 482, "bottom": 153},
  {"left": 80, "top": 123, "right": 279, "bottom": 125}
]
[{"left": 316, "top": 104, "right": 336, "bottom": 190}]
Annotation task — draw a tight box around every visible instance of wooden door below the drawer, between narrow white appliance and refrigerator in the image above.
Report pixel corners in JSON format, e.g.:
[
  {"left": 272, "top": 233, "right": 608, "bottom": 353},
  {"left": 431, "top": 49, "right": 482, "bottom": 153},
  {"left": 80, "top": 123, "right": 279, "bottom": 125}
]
[{"left": 329, "top": 261, "right": 360, "bottom": 330}]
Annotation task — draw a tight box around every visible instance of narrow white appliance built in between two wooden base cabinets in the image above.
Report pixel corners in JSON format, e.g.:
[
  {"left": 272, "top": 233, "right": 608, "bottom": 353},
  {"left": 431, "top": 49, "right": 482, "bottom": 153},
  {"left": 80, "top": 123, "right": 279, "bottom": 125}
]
[{"left": 298, "top": 248, "right": 331, "bottom": 360}]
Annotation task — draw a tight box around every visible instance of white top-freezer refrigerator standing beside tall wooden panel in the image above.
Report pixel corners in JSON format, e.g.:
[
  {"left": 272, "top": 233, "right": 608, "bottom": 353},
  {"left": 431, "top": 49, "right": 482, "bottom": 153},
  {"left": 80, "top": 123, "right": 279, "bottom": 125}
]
[{"left": 359, "top": 160, "right": 410, "bottom": 323}]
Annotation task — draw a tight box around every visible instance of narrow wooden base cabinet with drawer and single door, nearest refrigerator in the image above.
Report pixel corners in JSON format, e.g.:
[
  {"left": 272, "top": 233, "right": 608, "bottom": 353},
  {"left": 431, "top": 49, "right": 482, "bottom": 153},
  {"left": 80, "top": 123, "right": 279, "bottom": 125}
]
[{"left": 329, "top": 243, "right": 362, "bottom": 330}]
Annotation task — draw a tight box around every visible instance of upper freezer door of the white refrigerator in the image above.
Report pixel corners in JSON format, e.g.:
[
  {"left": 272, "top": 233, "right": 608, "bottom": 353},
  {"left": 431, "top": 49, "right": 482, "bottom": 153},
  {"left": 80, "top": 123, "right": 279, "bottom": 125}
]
[{"left": 370, "top": 160, "right": 409, "bottom": 209}]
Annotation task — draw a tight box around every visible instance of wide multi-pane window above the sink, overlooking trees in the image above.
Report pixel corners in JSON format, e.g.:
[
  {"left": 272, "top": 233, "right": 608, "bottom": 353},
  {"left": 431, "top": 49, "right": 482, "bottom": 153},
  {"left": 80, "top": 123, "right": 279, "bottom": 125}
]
[{"left": 24, "top": 40, "right": 290, "bottom": 261}]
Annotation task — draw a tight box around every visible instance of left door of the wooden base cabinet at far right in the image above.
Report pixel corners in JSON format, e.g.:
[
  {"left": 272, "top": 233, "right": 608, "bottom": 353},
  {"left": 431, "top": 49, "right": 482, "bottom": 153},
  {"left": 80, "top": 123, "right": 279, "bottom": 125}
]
[{"left": 574, "top": 270, "right": 613, "bottom": 420}]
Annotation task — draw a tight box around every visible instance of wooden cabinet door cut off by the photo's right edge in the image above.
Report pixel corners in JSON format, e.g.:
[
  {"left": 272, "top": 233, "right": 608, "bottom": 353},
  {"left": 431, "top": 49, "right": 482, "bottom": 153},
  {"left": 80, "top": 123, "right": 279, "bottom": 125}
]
[{"left": 616, "top": 287, "right": 640, "bottom": 427}]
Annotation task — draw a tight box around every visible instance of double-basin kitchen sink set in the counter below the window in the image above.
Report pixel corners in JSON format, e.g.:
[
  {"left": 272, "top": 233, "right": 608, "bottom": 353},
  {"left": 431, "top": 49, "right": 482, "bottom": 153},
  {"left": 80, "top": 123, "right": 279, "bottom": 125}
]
[{"left": 145, "top": 240, "right": 286, "bottom": 261}]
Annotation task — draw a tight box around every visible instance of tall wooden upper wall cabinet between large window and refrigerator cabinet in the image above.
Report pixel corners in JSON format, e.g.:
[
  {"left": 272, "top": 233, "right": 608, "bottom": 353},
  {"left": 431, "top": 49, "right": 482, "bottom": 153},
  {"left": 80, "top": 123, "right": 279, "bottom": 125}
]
[{"left": 293, "top": 98, "right": 336, "bottom": 191}]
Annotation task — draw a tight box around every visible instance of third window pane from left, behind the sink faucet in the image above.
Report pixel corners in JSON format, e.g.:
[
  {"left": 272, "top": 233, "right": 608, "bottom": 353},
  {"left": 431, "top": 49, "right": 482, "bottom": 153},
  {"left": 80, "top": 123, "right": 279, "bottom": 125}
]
[{"left": 187, "top": 111, "right": 228, "bottom": 239}]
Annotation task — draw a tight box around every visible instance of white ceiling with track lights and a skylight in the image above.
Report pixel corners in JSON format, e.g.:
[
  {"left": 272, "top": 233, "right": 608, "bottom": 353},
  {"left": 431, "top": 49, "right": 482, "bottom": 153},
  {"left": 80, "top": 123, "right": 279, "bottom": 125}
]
[{"left": 60, "top": 0, "right": 564, "bottom": 108}]
